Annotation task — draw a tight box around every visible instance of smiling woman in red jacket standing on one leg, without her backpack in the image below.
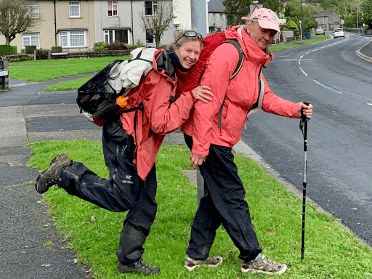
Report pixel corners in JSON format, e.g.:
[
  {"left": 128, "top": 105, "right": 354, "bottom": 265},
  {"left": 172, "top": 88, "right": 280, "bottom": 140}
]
[{"left": 35, "top": 31, "right": 212, "bottom": 274}]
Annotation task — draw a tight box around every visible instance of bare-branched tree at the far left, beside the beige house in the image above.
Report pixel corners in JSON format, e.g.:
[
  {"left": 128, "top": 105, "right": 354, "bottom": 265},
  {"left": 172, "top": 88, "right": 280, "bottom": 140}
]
[{"left": 0, "top": 0, "right": 35, "bottom": 44}]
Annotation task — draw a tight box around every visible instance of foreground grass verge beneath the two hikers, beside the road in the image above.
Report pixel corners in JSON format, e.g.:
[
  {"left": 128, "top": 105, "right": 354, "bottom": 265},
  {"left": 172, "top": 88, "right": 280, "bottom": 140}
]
[{"left": 30, "top": 140, "right": 372, "bottom": 279}]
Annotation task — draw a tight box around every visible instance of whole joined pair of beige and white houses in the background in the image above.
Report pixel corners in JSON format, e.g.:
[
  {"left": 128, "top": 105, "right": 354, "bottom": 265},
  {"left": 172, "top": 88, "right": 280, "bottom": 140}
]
[{"left": 0, "top": 0, "right": 174, "bottom": 52}]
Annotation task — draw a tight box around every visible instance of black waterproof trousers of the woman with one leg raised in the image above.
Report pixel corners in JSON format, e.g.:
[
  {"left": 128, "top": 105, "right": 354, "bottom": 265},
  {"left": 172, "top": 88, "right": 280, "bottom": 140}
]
[{"left": 59, "top": 123, "right": 157, "bottom": 265}]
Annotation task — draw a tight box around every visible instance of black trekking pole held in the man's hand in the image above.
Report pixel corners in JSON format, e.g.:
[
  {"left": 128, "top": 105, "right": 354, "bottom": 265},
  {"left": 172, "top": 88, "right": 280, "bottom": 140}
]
[{"left": 300, "top": 103, "right": 310, "bottom": 260}]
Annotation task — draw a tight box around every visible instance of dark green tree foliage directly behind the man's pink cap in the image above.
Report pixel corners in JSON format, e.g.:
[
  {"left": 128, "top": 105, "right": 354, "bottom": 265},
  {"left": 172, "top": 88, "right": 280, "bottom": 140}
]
[{"left": 223, "top": 0, "right": 286, "bottom": 26}]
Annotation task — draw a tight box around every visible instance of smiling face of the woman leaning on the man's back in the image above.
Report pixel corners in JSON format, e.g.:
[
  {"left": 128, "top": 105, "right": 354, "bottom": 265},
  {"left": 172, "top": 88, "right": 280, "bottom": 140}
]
[{"left": 174, "top": 40, "right": 201, "bottom": 69}]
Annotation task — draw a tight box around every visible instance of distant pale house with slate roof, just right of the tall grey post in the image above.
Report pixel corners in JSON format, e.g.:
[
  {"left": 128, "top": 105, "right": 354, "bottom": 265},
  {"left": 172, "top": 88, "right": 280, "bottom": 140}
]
[{"left": 208, "top": 0, "right": 227, "bottom": 33}]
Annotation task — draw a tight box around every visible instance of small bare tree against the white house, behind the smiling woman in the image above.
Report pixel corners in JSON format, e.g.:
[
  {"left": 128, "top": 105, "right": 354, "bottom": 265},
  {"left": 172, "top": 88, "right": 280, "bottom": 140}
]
[{"left": 141, "top": 0, "right": 175, "bottom": 48}]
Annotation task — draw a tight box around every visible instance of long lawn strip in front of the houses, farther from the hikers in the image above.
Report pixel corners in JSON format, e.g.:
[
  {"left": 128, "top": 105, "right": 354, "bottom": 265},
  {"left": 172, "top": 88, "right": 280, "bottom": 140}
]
[{"left": 9, "top": 56, "right": 130, "bottom": 81}]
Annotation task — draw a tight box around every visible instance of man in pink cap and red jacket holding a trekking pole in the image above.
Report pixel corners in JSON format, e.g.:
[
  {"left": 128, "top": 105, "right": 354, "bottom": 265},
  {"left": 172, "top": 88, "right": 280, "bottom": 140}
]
[{"left": 182, "top": 9, "right": 313, "bottom": 274}]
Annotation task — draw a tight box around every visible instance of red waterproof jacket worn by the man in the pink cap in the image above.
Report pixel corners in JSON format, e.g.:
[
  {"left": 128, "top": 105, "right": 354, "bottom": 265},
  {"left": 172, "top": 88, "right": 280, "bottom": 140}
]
[{"left": 182, "top": 26, "right": 300, "bottom": 157}]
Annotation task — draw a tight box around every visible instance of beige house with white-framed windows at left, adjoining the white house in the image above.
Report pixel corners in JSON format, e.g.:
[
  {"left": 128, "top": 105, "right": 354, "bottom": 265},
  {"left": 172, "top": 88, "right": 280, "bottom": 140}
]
[{"left": 0, "top": 1, "right": 95, "bottom": 52}]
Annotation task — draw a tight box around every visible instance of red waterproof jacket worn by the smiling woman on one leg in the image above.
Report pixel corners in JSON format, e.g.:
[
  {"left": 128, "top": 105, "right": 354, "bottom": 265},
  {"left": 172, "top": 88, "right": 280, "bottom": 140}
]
[{"left": 120, "top": 49, "right": 194, "bottom": 180}]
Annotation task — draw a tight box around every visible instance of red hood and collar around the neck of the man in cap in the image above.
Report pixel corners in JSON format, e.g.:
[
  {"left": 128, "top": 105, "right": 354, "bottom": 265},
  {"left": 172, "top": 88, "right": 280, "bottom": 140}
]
[{"left": 225, "top": 25, "right": 274, "bottom": 67}]
